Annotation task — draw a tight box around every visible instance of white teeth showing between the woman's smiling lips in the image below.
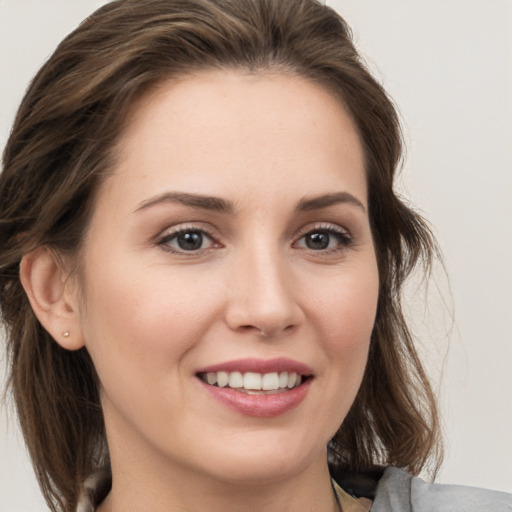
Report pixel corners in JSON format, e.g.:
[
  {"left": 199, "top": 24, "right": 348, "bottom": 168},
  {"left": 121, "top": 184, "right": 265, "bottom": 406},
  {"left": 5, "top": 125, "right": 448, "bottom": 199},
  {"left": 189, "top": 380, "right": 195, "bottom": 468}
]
[{"left": 197, "top": 371, "right": 310, "bottom": 395}]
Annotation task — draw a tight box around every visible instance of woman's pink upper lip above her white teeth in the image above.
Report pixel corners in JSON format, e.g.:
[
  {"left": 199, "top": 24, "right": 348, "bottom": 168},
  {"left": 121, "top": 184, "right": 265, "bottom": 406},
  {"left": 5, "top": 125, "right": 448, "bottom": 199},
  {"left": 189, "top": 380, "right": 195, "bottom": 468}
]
[{"left": 197, "top": 357, "right": 313, "bottom": 375}]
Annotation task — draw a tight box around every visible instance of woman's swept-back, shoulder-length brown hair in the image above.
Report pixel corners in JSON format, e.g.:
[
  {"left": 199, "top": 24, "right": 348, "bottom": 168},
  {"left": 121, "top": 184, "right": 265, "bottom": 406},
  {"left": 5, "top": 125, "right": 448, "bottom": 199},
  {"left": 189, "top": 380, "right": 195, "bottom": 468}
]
[{"left": 0, "top": 0, "right": 441, "bottom": 511}]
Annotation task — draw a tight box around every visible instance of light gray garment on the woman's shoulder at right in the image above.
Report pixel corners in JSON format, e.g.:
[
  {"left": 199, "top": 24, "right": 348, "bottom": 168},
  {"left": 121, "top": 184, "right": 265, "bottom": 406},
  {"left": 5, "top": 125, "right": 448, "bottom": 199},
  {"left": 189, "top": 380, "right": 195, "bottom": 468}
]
[{"left": 371, "top": 467, "right": 512, "bottom": 512}]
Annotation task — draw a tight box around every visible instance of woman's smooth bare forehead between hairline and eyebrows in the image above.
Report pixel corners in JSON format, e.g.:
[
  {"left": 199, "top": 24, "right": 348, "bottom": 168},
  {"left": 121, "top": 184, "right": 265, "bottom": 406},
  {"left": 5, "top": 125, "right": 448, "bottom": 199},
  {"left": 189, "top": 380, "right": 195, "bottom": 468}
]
[{"left": 102, "top": 70, "right": 366, "bottom": 210}]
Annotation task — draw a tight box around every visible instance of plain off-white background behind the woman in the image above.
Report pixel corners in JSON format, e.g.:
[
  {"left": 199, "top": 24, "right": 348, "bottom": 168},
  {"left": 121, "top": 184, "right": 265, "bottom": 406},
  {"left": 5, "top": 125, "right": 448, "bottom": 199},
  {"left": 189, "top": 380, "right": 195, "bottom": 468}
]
[{"left": 0, "top": 0, "right": 512, "bottom": 512}]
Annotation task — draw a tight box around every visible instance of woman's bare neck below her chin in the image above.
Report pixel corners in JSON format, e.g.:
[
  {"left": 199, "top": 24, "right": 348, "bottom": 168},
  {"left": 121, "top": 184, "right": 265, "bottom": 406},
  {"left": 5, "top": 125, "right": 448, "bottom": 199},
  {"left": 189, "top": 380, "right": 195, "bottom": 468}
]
[{"left": 98, "top": 446, "right": 339, "bottom": 512}]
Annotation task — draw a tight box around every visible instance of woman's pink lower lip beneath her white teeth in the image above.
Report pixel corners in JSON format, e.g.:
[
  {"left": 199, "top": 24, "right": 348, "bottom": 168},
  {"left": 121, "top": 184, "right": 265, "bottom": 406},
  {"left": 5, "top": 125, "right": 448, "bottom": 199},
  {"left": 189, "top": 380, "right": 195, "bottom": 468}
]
[{"left": 199, "top": 378, "right": 313, "bottom": 418}]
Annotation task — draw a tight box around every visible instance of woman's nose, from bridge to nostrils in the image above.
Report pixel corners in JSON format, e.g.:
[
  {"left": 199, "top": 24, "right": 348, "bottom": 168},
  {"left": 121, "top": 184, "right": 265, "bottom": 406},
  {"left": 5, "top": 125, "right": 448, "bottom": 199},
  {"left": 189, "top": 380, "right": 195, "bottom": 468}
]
[{"left": 226, "top": 246, "right": 304, "bottom": 336}]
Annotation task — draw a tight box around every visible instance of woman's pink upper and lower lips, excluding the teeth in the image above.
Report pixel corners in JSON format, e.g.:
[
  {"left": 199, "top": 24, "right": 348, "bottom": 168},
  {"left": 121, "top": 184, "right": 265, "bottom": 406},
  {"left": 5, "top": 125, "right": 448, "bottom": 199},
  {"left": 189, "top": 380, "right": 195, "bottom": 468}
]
[{"left": 197, "top": 358, "right": 313, "bottom": 418}]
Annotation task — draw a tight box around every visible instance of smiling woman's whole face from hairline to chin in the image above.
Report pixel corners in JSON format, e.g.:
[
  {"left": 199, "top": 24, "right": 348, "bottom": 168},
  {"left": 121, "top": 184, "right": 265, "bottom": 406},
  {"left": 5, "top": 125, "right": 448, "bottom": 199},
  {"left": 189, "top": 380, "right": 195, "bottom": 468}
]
[{"left": 80, "top": 71, "right": 378, "bottom": 482}]
